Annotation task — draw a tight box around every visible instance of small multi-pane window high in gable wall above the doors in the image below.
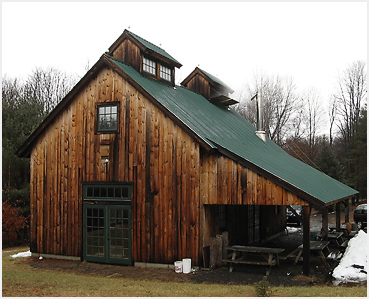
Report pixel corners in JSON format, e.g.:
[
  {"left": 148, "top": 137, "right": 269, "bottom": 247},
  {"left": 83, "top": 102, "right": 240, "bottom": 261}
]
[{"left": 97, "top": 103, "right": 118, "bottom": 133}]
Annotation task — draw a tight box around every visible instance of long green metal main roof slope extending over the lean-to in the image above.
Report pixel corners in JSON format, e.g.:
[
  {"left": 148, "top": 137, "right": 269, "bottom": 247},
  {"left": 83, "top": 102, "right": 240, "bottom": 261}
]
[{"left": 109, "top": 57, "right": 358, "bottom": 205}]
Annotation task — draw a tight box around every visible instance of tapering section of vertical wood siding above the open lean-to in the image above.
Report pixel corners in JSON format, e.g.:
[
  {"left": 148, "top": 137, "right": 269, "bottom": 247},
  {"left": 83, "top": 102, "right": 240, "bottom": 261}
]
[{"left": 200, "top": 154, "right": 307, "bottom": 206}]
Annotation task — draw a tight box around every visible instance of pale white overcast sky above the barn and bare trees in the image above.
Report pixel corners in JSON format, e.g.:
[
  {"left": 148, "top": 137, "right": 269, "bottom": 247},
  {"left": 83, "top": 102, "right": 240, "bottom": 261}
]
[{"left": 2, "top": 1, "right": 368, "bottom": 106}]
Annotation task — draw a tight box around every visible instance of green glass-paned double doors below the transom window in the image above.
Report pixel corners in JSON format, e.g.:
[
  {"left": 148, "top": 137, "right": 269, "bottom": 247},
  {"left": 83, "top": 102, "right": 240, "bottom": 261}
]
[{"left": 83, "top": 204, "right": 132, "bottom": 265}]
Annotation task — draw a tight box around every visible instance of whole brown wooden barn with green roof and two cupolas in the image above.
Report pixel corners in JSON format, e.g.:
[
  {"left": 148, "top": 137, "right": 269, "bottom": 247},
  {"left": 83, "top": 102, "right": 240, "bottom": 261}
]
[{"left": 18, "top": 30, "right": 357, "bottom": 276}]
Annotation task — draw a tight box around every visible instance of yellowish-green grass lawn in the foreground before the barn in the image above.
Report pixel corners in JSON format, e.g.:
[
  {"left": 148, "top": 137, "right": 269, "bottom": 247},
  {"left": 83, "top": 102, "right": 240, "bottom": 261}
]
[{"left": 2, "top": 248, "right": 367, "bottom": 297}]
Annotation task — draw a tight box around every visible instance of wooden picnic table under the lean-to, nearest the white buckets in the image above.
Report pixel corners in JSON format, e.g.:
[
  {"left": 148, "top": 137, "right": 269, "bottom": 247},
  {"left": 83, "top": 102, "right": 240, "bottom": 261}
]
[{"left": 223, "top": 245, "right": 284, "bottom": 275}]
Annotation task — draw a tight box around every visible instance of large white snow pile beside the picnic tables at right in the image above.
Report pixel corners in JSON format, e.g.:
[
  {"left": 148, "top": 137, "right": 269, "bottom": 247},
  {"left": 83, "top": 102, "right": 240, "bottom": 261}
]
[{"left": 332, "top": 230, "right": 368, "bottom": 285}]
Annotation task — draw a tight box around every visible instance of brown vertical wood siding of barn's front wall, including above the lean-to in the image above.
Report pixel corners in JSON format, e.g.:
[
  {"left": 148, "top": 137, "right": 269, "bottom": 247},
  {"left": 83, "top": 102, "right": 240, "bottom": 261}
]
[{"left": 30, "top": 67, "right": 305, "bottom": 265}]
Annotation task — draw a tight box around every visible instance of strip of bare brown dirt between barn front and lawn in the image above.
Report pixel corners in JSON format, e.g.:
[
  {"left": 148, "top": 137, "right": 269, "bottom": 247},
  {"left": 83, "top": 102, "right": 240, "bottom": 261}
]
[{"left": 19, "top": 253, "right": 327, "bottom": 286}]
